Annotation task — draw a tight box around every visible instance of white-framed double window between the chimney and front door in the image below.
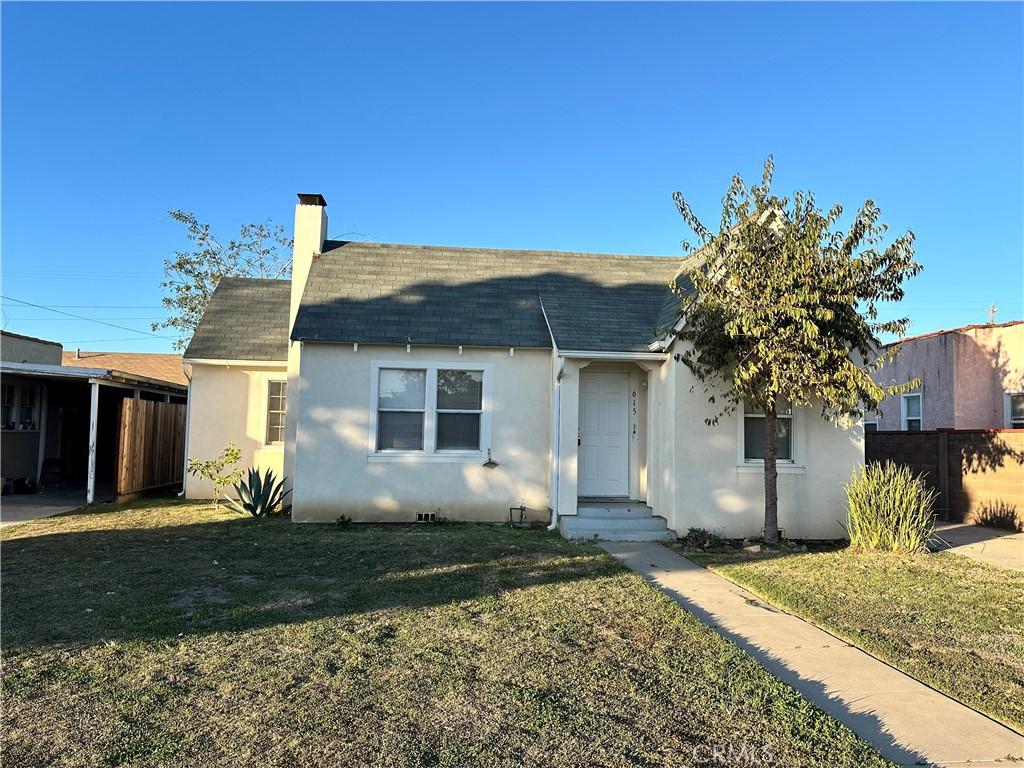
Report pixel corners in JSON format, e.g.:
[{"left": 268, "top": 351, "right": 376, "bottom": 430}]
[{"left": 371, "top": 362, "right": 489, "bottom": 461}]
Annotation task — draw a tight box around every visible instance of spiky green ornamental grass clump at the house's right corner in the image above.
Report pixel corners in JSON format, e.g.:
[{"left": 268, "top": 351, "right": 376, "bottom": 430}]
[{"left": 844, "top": 461, "right": 938, "bottom": 552}]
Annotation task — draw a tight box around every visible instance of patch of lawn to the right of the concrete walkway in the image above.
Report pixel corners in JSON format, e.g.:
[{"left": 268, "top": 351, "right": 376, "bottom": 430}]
[{"left": 688, "top": 549, "right": 1024, "bottom": 731}]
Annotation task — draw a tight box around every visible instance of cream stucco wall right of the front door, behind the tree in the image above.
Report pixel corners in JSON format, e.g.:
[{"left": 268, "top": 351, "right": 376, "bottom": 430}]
[{"left": 653, "top": 352, "right": 864, "bottom": 539}]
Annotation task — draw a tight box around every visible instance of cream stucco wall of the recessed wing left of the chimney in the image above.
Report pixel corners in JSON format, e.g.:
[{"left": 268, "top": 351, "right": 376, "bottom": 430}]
[{"left": 185, "top": 365, "right": 287, "bottom": 499}]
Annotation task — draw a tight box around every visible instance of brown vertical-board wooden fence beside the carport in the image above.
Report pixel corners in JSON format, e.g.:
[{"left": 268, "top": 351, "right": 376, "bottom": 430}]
[{"left": 117, "top": 398, "right": 185, "bottom": 496}]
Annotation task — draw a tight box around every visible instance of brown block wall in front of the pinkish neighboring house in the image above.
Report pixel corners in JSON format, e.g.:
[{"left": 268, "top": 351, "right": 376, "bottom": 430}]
[{"left": 864, "top": 429, "right": 1024, "bottom": 525}]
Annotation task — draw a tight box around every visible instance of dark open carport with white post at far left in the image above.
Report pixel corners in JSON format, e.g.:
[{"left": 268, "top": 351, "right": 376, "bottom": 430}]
[{"left": 0, "top": 361, "right": 187, "bottom": 504}]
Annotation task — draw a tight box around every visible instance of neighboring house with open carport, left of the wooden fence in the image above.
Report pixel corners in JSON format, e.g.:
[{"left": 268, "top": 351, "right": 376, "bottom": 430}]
[{"left": 0, "top": 332, "right": 187, "bottom": 502}]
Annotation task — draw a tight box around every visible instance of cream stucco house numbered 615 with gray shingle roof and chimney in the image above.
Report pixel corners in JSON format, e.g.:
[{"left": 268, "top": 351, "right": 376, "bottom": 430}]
[{"left": 185, "top": 195, "right": 863, "bottom": 538}]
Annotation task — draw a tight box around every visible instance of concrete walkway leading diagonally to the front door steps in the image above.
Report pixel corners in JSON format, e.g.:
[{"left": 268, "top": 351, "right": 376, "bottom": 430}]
[{"left": 601, "top": 542, "right": 1024, "bottom": 768}]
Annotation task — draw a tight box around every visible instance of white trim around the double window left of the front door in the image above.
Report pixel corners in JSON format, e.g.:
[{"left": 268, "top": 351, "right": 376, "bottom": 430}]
[{"left": 367, "top": 359, "right": 495, "bottom": 464}]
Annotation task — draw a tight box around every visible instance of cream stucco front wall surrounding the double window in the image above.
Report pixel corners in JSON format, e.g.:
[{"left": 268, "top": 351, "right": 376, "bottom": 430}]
[{"left": 292, "top": 343, "right": 552, "bottom": 522}]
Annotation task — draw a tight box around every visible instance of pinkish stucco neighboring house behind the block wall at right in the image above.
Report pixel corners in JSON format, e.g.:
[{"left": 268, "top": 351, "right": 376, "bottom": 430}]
[{"left": 864, "top": 321, "right": 1024, "bottom": 431}]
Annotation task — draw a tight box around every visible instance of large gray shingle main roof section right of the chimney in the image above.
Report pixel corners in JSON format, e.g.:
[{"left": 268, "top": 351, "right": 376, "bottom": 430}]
[{"left": 292, "top": 241, "right": 700, "bottom": 351}]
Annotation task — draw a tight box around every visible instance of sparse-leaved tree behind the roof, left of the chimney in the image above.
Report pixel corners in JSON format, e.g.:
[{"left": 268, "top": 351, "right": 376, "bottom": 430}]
[{"left": 153, "top": 214, "right": 292, "bottom": 349}]
